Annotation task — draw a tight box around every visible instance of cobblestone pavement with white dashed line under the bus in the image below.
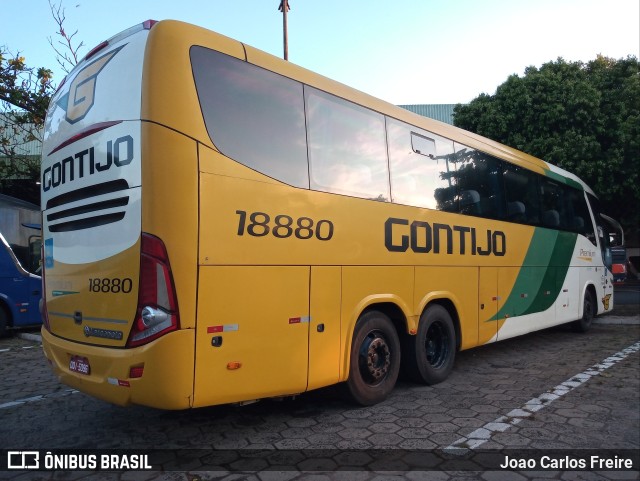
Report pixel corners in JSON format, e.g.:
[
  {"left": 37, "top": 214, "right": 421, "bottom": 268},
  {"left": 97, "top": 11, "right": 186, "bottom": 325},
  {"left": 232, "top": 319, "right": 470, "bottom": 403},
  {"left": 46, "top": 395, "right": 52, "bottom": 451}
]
[{"left": 0, "top": 316, "right": 640, "bottom": 481}]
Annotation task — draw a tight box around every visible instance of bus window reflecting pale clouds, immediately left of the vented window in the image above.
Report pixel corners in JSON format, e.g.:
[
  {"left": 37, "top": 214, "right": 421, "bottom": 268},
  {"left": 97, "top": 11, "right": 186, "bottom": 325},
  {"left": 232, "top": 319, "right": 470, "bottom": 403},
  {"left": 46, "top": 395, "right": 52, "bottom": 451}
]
[{"left": 305, "top": 86, "right": 391, "bottom": 202}]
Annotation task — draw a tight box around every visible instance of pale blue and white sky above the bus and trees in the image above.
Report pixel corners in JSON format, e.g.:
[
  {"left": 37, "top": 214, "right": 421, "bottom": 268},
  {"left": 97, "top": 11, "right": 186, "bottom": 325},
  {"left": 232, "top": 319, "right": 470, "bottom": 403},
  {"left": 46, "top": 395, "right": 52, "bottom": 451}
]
[{"left": 0, "top": 0, "right": 640, "bottom": 104}]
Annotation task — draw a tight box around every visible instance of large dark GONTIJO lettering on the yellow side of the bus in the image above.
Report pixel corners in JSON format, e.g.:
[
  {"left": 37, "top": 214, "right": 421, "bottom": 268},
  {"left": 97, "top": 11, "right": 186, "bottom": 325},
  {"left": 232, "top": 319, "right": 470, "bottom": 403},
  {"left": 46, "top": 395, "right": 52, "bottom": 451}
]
[{"left": 384, "top": 217, "right": 507, "bottom": 257}]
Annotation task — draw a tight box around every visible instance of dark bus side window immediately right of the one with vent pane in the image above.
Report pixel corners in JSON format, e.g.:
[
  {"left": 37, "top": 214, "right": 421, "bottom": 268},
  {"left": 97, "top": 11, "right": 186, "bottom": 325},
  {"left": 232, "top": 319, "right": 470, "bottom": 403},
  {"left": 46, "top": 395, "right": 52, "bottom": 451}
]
[{"left": 455, "top": 144, "right": 506, "bottom": 219}]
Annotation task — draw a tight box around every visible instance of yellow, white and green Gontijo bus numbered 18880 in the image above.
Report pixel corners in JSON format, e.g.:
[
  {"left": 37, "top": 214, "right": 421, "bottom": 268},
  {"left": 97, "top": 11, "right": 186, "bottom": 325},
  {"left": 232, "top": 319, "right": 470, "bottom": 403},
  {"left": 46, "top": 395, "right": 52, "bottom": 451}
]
[{"left": 41, "top": 21, "right": 613, "bottom": 409}]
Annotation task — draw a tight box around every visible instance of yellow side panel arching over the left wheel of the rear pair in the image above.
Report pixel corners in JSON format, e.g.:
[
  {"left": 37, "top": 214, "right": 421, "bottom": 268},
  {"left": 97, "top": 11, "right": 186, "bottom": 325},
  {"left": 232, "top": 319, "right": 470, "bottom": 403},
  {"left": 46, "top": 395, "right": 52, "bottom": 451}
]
[{"left": 340, "top": 266, "right": 418, "bottom": 381}]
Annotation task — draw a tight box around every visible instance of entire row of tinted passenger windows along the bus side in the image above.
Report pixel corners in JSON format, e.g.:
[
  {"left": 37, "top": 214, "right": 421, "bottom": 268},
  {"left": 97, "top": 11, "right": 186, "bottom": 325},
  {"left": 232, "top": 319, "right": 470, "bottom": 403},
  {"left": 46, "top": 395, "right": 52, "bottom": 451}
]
[{"left": 191, "top": 46, "right": 593, "bottom": 237}]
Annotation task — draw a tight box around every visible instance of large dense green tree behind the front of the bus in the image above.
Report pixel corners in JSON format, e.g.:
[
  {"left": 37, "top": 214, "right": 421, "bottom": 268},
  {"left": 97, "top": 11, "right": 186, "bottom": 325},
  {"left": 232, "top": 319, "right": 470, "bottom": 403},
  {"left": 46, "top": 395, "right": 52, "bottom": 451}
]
[{"left": 454, "top": 56, "right": 640, "bottom": 242}]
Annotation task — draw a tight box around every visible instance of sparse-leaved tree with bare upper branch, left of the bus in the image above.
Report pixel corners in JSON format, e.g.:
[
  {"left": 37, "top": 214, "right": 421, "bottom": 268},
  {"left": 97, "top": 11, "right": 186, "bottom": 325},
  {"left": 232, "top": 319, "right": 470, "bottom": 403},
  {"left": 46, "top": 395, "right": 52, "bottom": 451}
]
[{"left": 0, "top": 1, "right": 83, "bottom": 203}]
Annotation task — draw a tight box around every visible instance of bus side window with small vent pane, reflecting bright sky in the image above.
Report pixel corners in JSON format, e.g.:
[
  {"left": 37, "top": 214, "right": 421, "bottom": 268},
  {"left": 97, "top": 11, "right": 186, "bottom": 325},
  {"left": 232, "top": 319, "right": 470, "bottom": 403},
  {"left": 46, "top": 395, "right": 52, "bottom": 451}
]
[{"left": 387, "top": 119, "right": 457, "bottom": 211}]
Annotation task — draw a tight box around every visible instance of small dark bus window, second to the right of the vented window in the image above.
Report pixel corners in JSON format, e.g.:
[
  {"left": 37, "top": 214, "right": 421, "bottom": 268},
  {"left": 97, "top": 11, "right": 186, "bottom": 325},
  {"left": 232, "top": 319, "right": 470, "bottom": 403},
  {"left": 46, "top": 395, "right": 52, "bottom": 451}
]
[{"left": 502, "top": 162, "right": 540, "bottom": 225}]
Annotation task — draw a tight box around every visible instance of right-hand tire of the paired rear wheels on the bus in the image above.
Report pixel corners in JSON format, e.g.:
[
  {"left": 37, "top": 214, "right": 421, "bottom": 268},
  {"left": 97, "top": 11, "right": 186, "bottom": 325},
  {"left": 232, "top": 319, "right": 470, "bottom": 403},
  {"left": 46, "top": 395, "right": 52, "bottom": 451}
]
[{"left": 402, "top": 304, "right": 456, "bottom": 385}]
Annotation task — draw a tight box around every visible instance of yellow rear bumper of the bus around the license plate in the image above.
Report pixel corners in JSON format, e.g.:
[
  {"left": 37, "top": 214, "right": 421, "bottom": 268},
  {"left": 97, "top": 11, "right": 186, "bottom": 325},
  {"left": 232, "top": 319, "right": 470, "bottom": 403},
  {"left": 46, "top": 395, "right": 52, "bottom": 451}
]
[{"left": 42, "top": 327, "right": 195, "bottom": 409}]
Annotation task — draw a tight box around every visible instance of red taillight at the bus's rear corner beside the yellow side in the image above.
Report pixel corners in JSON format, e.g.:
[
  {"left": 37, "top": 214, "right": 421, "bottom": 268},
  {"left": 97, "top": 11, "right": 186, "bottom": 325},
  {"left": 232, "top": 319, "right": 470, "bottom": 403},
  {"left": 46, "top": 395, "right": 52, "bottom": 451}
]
[{"left": 127, "top": 234, "right": 179, "bottom": 347}]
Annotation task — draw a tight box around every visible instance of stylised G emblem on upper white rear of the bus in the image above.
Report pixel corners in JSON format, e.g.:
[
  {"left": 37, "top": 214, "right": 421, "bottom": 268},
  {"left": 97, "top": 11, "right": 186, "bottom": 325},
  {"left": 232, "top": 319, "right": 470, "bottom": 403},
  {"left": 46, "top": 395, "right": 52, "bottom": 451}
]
[{"left": 56, "top": 45, "right": 124, "bottom": 124}]
